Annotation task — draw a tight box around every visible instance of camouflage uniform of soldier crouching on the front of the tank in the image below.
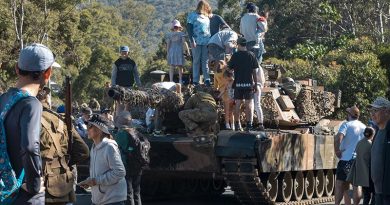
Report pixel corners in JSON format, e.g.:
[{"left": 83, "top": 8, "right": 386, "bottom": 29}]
[{"left": 179, "top": 92, "right": 218, "bottom": 132}]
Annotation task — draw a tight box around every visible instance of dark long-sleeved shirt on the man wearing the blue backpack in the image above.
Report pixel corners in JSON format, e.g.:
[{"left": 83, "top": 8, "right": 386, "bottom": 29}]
[{"left": 0, "top": 88, "right": 42, "bottom": 194}]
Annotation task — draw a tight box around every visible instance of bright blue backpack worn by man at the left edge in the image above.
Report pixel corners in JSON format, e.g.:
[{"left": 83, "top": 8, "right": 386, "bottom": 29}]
[{"left": 0, "top": 90, "right": 30, "bottom": 204}]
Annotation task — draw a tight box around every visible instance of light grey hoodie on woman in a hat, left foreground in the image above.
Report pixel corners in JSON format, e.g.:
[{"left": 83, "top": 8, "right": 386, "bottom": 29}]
[{"left": 89, "top": 138, "right": 127, "bottom": 205}]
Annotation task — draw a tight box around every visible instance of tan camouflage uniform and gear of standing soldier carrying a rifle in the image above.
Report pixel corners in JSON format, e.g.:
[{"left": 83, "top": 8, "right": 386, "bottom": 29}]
[{"left": 40, "top": 105, "right": 89, "bottom": 205}]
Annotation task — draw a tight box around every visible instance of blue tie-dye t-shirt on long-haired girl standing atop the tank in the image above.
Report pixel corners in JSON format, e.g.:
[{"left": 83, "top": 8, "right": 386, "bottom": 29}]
[{"left": 187, "top": 12, "right": 211, "bottom": 45}]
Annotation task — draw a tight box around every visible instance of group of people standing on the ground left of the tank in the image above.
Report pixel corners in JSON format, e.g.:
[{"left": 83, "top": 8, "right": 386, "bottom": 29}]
[{"left": 0, "top": 44, "right": 150, "bottom": 205}]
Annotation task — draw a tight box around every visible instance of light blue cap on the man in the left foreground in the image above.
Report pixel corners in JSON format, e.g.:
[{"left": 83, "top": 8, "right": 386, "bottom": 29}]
[{"left": 18, "top": 43, "right": 54, "bottom": 71}]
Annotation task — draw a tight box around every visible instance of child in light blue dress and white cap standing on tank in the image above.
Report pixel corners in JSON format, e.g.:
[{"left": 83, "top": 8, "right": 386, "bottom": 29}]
[{"left": 166, "top": 19, "right": 189, "bottom": 83}]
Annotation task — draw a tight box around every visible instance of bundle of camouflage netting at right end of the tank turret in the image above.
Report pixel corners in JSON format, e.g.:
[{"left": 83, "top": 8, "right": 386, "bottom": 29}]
[{"left": 294, "top": 88, "right": 336, "bottom": 124}]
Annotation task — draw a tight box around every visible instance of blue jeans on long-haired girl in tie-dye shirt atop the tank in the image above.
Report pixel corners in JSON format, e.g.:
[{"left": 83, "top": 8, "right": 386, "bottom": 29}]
[{"left": 192, "top": 45, "right": 210, "bottom": 84}]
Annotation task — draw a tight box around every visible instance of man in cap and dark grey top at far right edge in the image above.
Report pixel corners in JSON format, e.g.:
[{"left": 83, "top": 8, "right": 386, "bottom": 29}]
[{"left": 369, "top": 97, "right": 390, "bottom": 205}]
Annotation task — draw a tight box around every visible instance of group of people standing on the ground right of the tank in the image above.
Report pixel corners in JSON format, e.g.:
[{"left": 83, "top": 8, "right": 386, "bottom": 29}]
[{"left": 335, "top": 101, "right": 390, "bottom": 205}]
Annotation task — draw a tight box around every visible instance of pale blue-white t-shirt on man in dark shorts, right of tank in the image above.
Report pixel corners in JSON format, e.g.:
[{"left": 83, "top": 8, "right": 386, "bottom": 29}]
[{"left": 339, "top": 120, "right": 366, "bottom": 161}]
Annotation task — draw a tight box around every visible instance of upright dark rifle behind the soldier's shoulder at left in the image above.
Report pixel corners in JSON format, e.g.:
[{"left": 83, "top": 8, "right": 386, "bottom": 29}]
[{"left": 65, "top": 76, "right": 73, "bottom": 161}]
